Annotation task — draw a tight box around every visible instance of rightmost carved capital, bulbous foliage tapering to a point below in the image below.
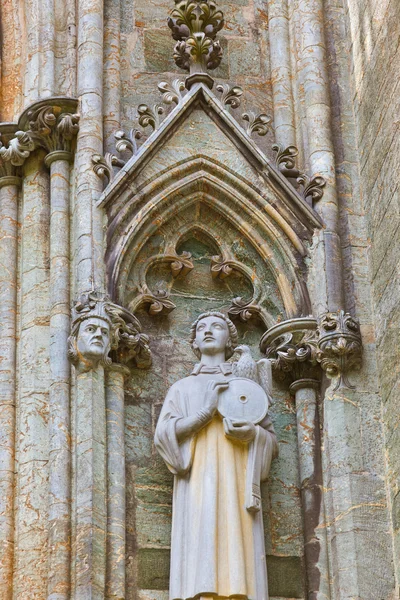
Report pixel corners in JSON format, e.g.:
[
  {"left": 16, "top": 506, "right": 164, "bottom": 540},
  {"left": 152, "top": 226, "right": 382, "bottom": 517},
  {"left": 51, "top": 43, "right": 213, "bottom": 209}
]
[{"left": 318, "top": 310, "right": 362, "bottom": 390}]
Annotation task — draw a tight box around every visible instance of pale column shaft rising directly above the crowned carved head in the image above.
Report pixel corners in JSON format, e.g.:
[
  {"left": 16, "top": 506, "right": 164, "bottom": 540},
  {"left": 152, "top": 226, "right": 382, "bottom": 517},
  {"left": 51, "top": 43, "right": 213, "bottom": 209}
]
[{"left": 73, "top": 0, "right": 105, "bottom": 296}]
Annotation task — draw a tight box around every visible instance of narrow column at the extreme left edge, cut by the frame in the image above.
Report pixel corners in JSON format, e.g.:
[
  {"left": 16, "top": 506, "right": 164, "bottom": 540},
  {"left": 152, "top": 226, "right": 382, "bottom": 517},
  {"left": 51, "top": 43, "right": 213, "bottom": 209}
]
[{"left": 0, "top": 124, "right": 21, "bottom": 600}]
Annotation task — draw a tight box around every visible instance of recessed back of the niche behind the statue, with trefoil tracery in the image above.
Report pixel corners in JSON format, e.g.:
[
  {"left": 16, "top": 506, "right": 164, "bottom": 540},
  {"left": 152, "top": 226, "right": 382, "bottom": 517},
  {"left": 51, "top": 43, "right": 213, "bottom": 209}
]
[{"left": 123, "top": 223, "right": 302, "bottom": 598}]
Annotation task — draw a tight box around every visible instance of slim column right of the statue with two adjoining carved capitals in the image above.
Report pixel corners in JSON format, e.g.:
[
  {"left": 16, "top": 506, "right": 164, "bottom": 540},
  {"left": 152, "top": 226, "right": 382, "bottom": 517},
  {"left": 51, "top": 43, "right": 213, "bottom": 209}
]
[{"left": 260, "top": 310, "right": 362, "bottom": 600}]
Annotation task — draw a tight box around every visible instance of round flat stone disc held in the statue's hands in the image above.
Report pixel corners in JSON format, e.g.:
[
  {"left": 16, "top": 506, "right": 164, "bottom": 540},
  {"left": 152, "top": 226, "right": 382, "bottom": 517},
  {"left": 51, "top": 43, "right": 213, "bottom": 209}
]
[{"left": 218, "top": 377, "right": 268, "bottom": 425}]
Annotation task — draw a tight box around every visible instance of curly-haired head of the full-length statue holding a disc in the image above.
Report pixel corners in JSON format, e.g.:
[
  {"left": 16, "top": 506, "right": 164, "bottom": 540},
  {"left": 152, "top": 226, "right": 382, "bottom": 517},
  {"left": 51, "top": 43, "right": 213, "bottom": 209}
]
[{"left": 190, "top": 311, "right": 237, "bottom": 358}]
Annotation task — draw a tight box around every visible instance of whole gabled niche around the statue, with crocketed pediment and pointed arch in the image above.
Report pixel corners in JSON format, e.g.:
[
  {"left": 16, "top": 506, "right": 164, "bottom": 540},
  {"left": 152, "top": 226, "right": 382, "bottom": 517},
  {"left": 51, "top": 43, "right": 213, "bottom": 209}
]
[{"left": 94, "top": 11, "right": 321, "bottom": 600}]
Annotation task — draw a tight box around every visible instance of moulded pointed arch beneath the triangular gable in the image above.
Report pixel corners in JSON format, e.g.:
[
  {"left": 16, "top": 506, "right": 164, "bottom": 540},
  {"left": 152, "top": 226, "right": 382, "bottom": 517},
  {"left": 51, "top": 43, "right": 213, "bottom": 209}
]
[{"left": 106, "top": 156, "right": 310, "bottom": 318}]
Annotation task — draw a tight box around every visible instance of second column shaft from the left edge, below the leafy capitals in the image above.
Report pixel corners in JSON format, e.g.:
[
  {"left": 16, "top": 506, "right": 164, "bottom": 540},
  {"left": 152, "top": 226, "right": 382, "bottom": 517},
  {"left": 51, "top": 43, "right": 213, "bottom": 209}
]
[{"left": 14, "top": 153, "right": 50, "bottom": 600}]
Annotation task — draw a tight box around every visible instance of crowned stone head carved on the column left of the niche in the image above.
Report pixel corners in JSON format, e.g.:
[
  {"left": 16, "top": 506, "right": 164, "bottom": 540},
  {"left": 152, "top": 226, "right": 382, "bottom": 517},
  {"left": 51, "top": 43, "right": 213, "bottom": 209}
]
[{"left": 68, "top": 298, "right": 115, "bottom": 367}]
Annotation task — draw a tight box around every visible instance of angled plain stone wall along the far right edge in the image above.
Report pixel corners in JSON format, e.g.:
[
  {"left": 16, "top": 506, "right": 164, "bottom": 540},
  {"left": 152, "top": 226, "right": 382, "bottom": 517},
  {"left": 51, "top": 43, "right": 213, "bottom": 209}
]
[{"left": 346, "top": 0, "right": 400, "bottom": 584}]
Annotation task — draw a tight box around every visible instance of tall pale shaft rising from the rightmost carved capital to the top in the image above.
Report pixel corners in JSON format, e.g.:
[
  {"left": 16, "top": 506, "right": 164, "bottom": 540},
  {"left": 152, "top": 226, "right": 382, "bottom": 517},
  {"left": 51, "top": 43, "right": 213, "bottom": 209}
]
[{"left": 292, "top": 0, "right": 344, "bottom": 315}]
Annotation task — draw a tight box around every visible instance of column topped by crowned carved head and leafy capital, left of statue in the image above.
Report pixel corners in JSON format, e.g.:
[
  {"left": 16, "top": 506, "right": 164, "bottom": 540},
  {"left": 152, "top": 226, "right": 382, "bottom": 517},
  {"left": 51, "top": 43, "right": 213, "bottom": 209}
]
[{"left": 69, "top": 292, "right": 150, "bottom": 600}]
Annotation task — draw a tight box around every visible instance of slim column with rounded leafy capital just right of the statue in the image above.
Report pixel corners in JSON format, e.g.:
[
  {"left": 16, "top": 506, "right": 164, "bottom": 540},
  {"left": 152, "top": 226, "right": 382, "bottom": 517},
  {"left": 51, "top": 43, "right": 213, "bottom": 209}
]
[{"left": 261, "top": 317, "right": 331, "bottom": 600}]
